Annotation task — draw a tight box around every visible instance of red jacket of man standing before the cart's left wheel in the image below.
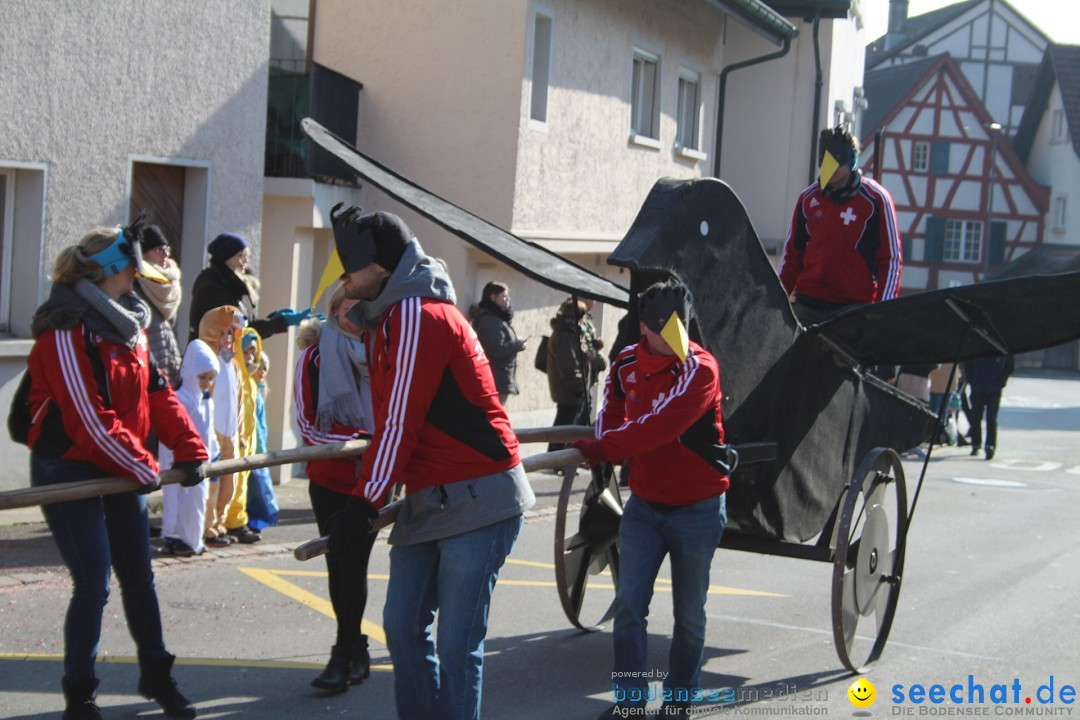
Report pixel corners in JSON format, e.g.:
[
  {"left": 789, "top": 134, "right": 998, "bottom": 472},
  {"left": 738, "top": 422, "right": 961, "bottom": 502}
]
[{"left": 596, "top": 339, "right": 730, "bottom": 505}]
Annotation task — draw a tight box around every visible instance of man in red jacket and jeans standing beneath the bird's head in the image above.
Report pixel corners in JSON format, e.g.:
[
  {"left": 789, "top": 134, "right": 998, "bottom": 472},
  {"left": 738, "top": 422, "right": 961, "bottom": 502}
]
[{"left": 572, "top": 283, "right": 731, "bottom": 719}]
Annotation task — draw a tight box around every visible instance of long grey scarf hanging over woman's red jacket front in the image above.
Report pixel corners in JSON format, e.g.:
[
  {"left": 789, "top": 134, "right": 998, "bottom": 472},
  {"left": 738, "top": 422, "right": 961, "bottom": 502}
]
[{"left": 315, "top": 303, "right": 375, "bottom": 432}]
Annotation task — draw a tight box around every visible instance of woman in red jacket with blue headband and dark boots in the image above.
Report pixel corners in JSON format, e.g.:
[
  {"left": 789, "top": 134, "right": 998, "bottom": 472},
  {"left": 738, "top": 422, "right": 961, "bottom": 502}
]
[{"left": 28, "top": 222, "right": 206, "bottom": 720}]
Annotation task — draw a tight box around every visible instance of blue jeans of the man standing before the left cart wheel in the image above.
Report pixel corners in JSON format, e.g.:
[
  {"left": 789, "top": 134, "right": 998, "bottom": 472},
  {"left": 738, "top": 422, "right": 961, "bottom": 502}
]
[{"left": 611, "top": 495, "right": 727, "bottom": 707}]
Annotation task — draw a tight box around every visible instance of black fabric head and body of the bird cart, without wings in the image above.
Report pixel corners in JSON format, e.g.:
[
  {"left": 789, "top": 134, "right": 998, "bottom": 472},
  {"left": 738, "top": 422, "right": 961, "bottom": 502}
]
[{"left": 608, "top": 178, "right": 934, "bottom": 542}]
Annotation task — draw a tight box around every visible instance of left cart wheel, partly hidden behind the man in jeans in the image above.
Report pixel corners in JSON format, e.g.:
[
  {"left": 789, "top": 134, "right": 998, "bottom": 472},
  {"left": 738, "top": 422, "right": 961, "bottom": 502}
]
[{"left": 555, "top": 463, "right": 622, "bottom": 631}]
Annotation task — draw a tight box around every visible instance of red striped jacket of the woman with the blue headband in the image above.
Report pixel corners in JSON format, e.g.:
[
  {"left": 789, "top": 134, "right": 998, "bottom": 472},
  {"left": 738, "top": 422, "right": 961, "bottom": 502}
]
[{"left": 28, "top": 322, "right": 206, "bottom": 485}]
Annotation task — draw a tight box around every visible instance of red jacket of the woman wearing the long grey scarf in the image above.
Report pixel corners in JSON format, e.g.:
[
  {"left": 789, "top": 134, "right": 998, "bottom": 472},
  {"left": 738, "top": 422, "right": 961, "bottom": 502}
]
[{"left": 293, "top": 343, "right": 367, "bottom": 494}]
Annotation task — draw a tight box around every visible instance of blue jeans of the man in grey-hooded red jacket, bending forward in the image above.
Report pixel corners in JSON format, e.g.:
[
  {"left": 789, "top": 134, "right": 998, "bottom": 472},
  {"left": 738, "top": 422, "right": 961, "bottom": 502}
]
[{"left": 382, "top": 515, "right": 523, "bottom": 720}]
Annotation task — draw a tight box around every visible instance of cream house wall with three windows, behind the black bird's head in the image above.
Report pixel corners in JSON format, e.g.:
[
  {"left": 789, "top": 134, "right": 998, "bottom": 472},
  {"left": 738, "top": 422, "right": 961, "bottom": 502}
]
[{"left": 513, "top": 0, "right": 725, "bottom": 241}]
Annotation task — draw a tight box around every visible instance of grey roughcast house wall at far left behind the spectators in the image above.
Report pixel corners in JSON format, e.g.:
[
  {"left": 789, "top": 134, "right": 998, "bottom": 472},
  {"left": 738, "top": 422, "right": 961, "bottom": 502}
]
[{"left": 0, "top": 0, "right": 270, "bottom": 496}]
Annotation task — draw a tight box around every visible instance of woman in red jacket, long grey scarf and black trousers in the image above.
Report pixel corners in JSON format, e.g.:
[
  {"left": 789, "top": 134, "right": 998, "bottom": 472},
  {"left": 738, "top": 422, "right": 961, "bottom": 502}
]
[{"left": 294, "top": 288, "right": 375, "bottom": 692}]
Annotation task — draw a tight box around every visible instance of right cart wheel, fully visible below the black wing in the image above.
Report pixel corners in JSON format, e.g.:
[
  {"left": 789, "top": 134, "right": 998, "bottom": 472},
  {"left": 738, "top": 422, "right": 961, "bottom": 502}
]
[{"left": 833, "top": 448, "right": 907, "bottom": 673}]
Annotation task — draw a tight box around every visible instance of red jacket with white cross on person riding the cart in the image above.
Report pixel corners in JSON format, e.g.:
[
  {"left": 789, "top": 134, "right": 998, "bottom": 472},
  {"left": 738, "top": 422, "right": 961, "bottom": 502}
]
[{"left": 780, "top": 177, "right": 904, "bottom": 303}]
